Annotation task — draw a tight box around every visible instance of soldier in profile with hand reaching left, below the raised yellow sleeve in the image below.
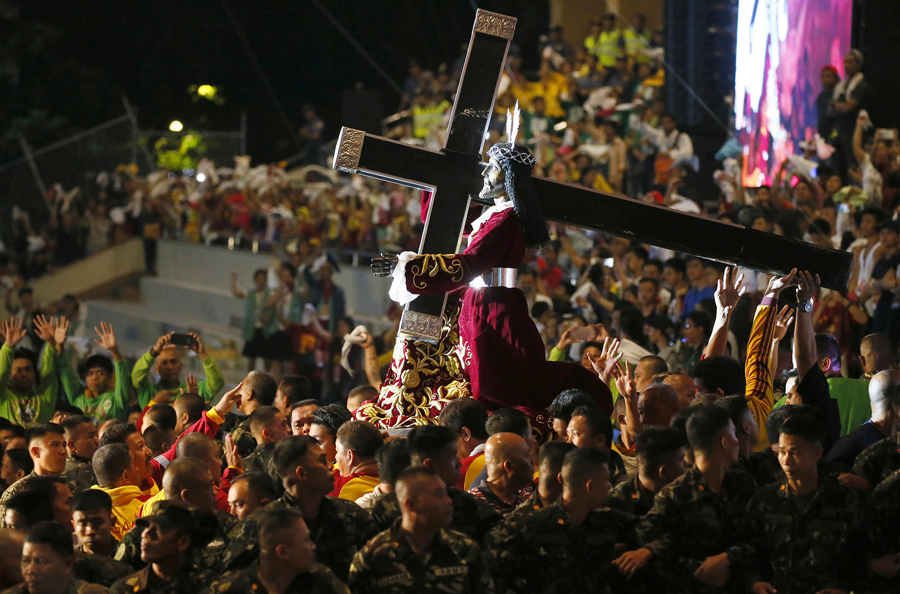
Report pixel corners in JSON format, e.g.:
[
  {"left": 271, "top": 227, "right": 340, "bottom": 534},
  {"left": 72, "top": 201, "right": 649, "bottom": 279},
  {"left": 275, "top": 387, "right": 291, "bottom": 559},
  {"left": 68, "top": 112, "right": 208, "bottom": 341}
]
[{"left": 626, "top": 404, "right": 756, "bottom": 592}]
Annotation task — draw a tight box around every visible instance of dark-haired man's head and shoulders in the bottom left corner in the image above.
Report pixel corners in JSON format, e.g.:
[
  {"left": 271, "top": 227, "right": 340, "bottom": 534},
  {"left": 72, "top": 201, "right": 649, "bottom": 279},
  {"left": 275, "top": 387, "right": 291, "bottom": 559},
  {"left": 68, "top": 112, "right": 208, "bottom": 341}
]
[{"left": 12, "top": 522, "right": 106, "bottom": 594}]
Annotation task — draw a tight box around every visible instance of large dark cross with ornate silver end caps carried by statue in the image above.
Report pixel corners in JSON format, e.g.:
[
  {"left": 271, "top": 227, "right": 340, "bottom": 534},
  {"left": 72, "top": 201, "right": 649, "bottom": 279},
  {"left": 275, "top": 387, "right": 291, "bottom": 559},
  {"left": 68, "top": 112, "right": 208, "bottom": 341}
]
[{"left": 333, "top": 9, "right": 852, "bottom": 341}]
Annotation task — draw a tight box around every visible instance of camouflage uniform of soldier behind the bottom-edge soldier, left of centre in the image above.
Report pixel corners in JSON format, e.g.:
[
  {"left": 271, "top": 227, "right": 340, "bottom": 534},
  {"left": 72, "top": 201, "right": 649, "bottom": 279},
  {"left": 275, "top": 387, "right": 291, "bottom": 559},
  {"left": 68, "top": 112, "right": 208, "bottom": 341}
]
[{"left": 222, "top": 493, "right": 376, "bottom": 580}]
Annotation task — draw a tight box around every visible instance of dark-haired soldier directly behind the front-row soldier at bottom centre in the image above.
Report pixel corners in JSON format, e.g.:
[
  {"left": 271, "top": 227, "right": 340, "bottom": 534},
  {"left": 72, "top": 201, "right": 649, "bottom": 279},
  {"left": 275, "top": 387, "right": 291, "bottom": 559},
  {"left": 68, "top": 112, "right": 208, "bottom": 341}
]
[{"left": 372, "top": 425, "right": 500, "bottom": 542}]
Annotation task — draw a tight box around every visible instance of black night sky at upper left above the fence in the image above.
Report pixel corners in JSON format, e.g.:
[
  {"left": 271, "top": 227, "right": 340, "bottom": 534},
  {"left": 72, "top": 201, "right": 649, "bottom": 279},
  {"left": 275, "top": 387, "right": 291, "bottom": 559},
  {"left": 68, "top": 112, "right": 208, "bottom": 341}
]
[{"left": 0, "top": 0, "right": 549, "bottom": 163}]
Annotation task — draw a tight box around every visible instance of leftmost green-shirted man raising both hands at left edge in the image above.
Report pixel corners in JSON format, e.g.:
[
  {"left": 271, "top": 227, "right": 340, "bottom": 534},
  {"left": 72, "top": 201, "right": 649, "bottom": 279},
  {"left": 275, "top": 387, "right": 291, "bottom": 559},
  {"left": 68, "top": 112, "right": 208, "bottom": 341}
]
[{"left": 0, "top": 318, "right": 59, "bottom": 427}]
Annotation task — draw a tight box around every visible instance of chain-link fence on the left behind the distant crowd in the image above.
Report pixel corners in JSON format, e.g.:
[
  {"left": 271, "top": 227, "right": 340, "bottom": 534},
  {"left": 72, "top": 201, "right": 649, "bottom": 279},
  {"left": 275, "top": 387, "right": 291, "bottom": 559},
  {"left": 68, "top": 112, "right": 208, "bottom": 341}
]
[{"left": 0, "top": 100, "right": 245, "bottom": 238}]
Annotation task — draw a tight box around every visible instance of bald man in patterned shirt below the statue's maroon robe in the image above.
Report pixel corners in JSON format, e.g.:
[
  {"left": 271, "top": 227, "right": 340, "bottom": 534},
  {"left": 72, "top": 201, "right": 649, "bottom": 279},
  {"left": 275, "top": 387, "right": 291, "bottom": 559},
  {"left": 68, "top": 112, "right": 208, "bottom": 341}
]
[{"left": 469, "top": 433, "right": 534, "bottom": 515}]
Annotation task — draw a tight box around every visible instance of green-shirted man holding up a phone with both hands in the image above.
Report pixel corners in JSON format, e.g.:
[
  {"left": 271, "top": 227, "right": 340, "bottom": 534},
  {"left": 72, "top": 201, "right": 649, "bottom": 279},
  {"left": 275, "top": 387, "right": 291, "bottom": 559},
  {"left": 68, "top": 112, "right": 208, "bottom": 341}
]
[{"left": 131, "top": 332, "right": 225, "bottom": 408}]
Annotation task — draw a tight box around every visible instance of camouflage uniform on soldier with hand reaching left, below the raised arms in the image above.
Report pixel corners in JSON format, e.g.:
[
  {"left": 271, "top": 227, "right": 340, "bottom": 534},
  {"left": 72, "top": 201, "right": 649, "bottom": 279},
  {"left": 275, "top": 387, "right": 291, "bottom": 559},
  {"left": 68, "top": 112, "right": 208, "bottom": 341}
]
[{"left": 638, "top": 465, "right": 756, "bottom": 592}]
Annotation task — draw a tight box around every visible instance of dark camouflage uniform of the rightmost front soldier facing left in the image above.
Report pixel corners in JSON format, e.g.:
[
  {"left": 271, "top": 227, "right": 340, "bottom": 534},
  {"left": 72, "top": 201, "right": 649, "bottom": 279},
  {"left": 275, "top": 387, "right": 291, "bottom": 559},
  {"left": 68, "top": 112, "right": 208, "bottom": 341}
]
[{"left": 740, "top": 479, "right": 862, "bottom": 594}]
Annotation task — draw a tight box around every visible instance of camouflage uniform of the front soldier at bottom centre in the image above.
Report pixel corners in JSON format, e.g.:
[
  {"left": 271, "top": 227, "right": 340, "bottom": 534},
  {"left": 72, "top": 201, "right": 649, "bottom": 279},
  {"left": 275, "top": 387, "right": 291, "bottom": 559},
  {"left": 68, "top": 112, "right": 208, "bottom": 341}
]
[{"left": 348, "top": 520, "right": 494, "bottom": 594}]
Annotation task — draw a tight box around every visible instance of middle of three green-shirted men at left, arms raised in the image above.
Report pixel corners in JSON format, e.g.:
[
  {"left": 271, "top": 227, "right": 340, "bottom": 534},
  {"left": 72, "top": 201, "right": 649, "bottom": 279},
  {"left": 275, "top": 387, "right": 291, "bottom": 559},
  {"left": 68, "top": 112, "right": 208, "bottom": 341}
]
[{"left": 59, "top": 322, "right": 131, "bottom": 425}]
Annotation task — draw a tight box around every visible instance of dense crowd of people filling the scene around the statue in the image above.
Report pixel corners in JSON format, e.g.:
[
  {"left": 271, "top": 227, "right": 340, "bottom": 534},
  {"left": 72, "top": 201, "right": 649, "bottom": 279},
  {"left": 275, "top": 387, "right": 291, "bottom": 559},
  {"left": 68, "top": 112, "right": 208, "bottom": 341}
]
[{"left": 0, "top": 8, "right": 900, "bottom": 594}]
